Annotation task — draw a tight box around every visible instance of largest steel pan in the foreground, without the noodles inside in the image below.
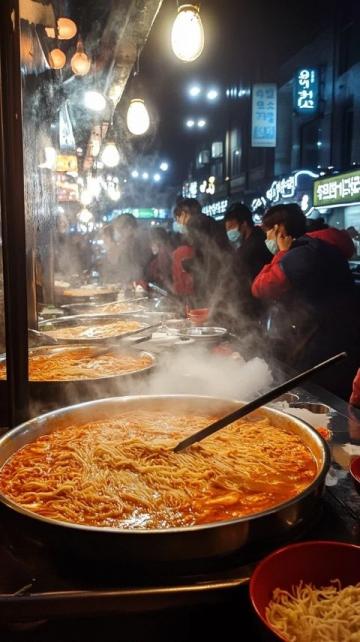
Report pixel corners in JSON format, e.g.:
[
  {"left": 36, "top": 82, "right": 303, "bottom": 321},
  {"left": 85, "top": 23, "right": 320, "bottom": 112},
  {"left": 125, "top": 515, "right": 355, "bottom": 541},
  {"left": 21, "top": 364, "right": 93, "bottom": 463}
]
[{"left": 0, "top": 395, "right": 330, "bottom": 567}]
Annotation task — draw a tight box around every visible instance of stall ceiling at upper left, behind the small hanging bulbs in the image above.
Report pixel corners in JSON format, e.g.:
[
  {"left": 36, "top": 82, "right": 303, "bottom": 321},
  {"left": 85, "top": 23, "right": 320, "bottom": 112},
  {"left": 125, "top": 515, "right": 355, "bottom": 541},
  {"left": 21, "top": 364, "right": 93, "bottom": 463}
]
[{"left": 20, "top": 0, "right": 163, "bottom": 170}]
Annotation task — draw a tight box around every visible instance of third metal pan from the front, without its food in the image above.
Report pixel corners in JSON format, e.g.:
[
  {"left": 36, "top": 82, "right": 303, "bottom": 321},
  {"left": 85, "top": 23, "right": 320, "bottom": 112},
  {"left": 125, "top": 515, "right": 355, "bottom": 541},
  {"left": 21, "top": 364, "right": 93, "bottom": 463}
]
[{"left": 38, "top": 314, "right": 151, "bottom": 345}]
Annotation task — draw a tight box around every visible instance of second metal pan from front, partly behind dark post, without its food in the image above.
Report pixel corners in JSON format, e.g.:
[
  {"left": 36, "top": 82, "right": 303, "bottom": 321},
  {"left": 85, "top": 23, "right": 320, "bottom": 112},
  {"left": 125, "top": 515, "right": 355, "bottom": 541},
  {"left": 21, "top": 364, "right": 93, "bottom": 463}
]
[{"left": 0, "top": 344, "right": 156, "bottom": 414}]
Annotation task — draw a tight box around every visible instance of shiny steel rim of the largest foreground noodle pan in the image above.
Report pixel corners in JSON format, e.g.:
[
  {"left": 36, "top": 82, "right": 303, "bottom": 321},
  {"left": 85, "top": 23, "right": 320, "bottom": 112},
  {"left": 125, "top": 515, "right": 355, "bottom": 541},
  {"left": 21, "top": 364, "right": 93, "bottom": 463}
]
[{"left": 0, "top": 394, "right": 331, "bottom": 538}]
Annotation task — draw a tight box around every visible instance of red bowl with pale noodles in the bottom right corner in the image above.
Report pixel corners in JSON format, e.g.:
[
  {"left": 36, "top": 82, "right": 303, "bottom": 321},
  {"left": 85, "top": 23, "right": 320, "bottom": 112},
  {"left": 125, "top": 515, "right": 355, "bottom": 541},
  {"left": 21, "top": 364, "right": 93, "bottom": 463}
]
[{"left": 250, "top": 541, "right": 360, "bottom": 642}]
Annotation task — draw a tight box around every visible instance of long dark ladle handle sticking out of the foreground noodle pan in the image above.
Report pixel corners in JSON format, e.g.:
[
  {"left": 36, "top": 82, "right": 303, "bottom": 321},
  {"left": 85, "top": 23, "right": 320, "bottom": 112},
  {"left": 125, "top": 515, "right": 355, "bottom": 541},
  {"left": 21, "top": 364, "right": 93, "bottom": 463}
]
[{"left": 174, "top": 352, "right": 347, "bottom": 453}]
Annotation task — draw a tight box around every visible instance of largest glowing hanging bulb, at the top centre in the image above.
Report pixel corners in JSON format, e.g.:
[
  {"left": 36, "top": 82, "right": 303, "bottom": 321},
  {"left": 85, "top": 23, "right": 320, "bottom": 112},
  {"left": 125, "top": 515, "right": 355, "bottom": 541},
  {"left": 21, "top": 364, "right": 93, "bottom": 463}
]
[{"left": 171, "top": 4, "right": 204, "bottom": 62}]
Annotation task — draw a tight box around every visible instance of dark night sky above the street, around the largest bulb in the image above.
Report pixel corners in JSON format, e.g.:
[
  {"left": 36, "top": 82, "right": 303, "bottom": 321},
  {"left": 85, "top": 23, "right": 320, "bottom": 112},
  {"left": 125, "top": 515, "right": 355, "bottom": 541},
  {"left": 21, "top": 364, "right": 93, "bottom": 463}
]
[{"left": 136, "top": 0, "right": 336, "bottom": 180}]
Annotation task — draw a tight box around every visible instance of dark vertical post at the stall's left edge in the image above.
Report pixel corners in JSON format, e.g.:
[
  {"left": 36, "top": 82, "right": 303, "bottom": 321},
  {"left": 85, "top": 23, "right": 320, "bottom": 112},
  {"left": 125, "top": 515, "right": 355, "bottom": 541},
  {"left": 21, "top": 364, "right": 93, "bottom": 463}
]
[{"left": 0, "top": 0, "right": 29, "bottom": 427}]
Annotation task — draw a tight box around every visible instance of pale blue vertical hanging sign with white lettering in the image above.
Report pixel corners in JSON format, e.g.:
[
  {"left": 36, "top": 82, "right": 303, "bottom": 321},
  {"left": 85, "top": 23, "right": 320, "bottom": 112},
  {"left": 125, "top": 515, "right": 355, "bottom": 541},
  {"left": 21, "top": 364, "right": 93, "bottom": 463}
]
[{"left": 251, "top": 83, "right": 277, "bottom": 147}]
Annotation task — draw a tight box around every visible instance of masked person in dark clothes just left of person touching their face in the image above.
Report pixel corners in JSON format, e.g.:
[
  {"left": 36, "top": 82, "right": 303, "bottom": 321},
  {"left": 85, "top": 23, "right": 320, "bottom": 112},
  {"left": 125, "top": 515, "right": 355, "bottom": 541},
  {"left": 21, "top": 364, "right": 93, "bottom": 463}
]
[{"left": 224, "top": 203, "right": 272, "bottom": 329}]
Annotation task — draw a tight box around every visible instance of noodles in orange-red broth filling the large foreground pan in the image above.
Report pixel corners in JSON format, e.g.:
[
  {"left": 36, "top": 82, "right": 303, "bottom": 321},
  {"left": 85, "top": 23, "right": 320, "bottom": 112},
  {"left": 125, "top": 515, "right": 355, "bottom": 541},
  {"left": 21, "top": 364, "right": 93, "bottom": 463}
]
[{"left": 0, "top": 410, "right": 317, "bottom": 529}]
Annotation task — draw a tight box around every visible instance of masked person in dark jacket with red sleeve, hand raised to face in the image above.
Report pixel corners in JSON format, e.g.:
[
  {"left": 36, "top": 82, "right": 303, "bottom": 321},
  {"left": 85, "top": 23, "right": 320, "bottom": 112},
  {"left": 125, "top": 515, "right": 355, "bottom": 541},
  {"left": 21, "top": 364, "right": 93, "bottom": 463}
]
[{"left": 252, "top": 203, "right": 360, "bottom": 399}]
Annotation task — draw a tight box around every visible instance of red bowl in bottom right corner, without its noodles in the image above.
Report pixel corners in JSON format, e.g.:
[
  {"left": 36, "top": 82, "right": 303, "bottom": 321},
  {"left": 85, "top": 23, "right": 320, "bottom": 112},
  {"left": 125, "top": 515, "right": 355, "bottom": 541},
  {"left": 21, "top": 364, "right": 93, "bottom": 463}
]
[{"left": 250, "top": 541, "right": 360, "bottom": 640}]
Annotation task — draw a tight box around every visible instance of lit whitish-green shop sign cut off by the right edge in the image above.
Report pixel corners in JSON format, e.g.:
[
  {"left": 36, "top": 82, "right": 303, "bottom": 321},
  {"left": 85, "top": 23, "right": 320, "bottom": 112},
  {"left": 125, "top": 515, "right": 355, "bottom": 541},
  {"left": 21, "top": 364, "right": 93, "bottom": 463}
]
[{"left": 314, "top": 169, "right": 360, "bottom": 207}]
